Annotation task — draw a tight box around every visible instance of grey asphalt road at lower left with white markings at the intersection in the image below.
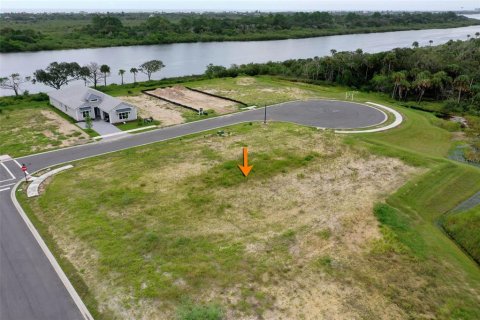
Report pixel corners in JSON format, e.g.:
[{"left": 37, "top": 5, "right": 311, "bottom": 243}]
[{"left": 0, "top": 160, "right": 83, "bottom": 320}]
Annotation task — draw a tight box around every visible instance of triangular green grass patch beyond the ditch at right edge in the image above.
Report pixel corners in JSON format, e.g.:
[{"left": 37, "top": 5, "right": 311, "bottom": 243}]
[{"left": 442, "top": 206, "right": 480, "bottom": 264}]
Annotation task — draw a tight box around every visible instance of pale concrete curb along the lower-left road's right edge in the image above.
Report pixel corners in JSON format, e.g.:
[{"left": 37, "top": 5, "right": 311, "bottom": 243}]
[{"left": 10, "top": 180, "right": 93, "bottom": 320}]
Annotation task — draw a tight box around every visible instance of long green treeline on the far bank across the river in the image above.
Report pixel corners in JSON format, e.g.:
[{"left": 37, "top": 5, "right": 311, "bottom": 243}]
[{"left": 0, "top": 12, "right": 480, "bottom": 52}]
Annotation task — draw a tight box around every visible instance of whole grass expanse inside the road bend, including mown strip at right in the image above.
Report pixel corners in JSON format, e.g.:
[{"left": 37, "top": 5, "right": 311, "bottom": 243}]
[{"left": 16, "top": 96, "right": 480, "bottom": 319}]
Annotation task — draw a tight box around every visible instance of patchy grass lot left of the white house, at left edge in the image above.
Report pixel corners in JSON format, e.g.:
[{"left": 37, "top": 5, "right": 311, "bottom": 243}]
[{"left": 0, "top": 101, "right": 88, "bottom": 157}]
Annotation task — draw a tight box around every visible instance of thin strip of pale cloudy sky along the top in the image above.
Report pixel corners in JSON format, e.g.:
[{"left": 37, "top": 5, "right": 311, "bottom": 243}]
[{"left": 0, "top": 0, "right": 480, "bottom": 12}]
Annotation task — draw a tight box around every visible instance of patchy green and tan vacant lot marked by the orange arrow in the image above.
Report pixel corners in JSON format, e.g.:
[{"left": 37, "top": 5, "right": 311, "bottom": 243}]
[{"left": 21, "top": 124, "right": 424, "bottom": 318}]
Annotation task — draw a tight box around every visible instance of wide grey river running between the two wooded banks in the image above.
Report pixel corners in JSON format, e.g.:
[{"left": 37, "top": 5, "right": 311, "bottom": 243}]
[{"left": 0, "top": 26, "right": 480, "bottom": 95}]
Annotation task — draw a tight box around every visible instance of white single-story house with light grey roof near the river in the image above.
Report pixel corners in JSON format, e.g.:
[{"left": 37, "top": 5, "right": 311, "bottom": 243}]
[{"left": 47, "top": 85, "right": 137, "bottom": 123}]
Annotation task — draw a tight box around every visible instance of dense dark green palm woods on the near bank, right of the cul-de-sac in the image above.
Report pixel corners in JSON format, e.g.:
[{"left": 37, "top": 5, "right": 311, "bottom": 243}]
[{"left": 206, "top": 38, "right": 480, "bottom": 115}]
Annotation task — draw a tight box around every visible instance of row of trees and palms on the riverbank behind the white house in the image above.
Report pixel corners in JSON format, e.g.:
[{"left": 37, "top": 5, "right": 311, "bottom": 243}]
[{"left": 0, "top": 60, "right": 165, "bottom": 96}]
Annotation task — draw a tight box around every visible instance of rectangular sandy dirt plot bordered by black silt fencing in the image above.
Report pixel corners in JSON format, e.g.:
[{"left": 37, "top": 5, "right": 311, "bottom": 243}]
[{"left": 148, "top": 86, "right": 237, "bottom": 114}]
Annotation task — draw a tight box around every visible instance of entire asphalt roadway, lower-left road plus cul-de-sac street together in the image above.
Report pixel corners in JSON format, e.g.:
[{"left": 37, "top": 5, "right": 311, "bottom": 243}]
[{"left": 0, "top": 101, "right": 385, "bottom": 320}]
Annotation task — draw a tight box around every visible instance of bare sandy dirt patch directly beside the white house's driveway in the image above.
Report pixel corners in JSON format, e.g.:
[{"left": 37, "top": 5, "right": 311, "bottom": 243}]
[{"left": 119, "top": 94, "right": 185, "bottom": 126}]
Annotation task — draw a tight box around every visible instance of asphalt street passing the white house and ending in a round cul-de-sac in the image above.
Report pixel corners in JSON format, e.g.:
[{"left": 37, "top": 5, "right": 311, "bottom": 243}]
[{"left": 18, "top": 100, "right": 386, "bottom": 171}]
